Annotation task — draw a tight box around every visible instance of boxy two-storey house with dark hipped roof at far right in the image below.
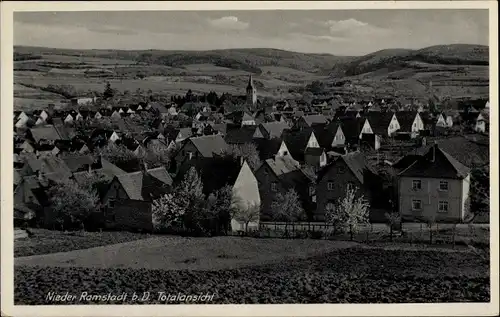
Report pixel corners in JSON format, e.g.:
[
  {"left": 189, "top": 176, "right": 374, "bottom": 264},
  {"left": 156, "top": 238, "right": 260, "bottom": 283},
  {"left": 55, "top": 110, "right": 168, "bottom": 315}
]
[{"left": 397, "top": 144, "right": 470, "bottom": 222}]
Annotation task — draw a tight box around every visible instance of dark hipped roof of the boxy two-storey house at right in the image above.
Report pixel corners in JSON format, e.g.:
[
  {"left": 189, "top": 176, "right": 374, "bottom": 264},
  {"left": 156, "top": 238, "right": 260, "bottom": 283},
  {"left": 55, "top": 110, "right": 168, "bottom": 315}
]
[{"left": 399, "top": 144, "right": 470, "bottom": 179}]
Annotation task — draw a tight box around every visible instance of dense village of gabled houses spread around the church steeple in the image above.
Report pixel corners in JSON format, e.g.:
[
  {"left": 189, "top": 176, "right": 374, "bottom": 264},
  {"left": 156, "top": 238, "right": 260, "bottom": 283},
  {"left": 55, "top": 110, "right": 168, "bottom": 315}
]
[{"left": 14, "top": 76, "right": 489, "bottom": 235}]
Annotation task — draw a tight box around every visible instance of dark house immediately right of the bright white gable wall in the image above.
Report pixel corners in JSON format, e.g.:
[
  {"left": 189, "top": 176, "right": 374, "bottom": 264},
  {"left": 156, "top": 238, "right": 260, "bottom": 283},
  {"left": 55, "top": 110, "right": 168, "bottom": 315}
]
[{"left": 255, "top": 156, "right": 314, "bottom": 221}]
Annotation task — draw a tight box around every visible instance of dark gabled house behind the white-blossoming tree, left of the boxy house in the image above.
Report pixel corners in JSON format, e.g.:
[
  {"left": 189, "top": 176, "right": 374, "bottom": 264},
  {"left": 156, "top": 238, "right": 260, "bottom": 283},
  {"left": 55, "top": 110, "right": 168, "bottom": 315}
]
[{"left": 313, "top": 151, "right": 382, "bottom": 221}]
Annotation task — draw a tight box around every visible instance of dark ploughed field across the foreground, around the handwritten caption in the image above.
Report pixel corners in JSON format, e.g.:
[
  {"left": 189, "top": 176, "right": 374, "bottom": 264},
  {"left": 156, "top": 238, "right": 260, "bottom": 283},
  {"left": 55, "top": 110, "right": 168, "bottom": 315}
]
[{"left": 14, "top": 239, "right": 490, "bottom": 305}]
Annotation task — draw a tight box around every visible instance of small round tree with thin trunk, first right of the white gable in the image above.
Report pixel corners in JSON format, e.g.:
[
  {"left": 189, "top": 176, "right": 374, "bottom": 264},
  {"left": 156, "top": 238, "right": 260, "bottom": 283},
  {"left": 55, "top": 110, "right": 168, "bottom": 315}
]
[{"left": 271, "top": 188, "right": 305, "bottom": 235}]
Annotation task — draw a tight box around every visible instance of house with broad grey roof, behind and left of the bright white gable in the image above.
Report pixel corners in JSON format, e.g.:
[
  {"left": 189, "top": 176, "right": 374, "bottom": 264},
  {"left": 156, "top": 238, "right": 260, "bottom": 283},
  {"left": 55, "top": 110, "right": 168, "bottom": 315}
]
[{"left": 172, "top": 134, "right": 228, "bottom": 168}]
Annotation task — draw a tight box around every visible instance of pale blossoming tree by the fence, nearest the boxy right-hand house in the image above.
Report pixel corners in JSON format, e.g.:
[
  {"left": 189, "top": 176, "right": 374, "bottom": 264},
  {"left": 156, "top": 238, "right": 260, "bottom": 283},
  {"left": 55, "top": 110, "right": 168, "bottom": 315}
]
[{"left": 327, "top": 186, "right": 370, "bottom": 239}]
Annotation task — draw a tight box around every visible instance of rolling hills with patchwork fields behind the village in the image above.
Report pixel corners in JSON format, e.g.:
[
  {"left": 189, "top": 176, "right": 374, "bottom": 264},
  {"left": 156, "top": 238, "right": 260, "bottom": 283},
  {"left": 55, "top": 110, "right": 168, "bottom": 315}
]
[{"left": 14, "top": 44, "right": 489, "bottom": 106}]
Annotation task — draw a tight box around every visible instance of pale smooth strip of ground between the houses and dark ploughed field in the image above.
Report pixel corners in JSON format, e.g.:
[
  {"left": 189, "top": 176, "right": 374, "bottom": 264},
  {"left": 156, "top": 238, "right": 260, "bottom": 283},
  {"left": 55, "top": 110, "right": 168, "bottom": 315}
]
[{"left": 14, "top": 236, "right": 359, "bottom": 270}]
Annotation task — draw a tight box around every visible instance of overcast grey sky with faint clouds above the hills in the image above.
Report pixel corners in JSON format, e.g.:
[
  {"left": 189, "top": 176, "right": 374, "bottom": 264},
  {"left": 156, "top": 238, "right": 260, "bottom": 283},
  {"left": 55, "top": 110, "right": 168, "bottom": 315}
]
[{"left": 14, "top": 10, "right": 488, "bottom": 55}]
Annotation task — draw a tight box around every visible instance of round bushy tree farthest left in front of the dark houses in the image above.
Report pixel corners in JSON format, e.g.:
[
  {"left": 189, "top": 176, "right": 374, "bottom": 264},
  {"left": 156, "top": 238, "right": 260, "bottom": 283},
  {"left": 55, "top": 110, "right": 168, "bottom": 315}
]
[{"left": 49, "top": 180, "right": 99, "bottom": 230}]
